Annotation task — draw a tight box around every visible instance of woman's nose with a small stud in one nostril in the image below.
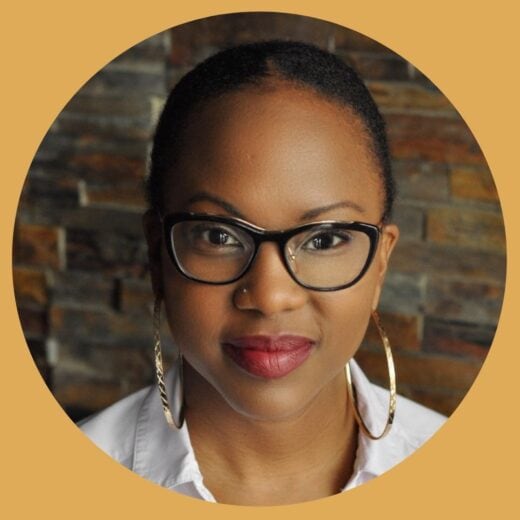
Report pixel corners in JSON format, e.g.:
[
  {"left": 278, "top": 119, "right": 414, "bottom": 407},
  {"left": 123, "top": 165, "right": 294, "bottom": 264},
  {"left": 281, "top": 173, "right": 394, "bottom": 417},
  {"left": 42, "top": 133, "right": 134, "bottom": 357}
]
[{"left": 234, "top": 242, "right": 309, "bottom": 317}]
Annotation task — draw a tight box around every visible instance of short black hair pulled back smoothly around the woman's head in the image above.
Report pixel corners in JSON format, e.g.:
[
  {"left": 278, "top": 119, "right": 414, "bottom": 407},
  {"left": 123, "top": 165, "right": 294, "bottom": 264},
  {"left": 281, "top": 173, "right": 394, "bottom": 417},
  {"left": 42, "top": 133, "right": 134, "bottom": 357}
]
[{"left": 146, "top": 40, "right": 395, "bottom": 221}]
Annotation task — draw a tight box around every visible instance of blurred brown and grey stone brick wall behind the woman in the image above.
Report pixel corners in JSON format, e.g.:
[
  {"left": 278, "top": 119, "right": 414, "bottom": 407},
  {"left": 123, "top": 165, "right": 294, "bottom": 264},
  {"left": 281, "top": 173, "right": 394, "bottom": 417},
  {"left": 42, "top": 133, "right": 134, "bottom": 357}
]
[{"left": 13, "top": 13, "right": 505, "bottom": 419}]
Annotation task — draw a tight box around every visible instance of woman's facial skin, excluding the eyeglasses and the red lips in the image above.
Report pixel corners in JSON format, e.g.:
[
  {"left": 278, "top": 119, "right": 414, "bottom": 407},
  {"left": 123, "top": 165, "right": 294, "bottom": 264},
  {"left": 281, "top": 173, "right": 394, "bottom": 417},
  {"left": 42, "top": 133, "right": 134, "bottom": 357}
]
[{"left": 147, "top": 84, "right": 398, "bottom": 420}]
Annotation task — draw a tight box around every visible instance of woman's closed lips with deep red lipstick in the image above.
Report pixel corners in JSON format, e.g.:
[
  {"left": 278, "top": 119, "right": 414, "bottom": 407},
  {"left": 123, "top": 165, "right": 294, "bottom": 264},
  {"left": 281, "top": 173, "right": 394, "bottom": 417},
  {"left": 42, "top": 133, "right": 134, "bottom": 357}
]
[{"left": 223, "top": 334, "right": 315, "bottom": 379}]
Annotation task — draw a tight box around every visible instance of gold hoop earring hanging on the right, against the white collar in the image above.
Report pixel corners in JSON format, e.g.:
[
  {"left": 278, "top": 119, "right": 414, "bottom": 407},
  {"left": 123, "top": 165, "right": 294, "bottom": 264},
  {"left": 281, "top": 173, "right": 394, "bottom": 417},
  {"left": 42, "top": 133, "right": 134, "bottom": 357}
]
[{"left": 345, "top": 311, "right": 397, "bottom": 440}]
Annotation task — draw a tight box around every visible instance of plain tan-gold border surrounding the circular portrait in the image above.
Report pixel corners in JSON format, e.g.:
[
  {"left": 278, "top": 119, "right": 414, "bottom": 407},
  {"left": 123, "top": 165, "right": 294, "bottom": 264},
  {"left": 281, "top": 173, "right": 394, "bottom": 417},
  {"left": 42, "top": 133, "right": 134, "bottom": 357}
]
[{"left": 0, "top": 0, "right": 520, "bottom": 519}]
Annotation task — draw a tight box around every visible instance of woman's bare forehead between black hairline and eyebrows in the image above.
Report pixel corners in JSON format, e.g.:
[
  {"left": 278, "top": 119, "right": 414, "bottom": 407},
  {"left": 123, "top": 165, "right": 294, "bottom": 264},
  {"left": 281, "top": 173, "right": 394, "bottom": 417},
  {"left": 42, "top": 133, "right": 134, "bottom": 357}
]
[{"left": 165, "top": 86, "right": 382, "bottom": 227}]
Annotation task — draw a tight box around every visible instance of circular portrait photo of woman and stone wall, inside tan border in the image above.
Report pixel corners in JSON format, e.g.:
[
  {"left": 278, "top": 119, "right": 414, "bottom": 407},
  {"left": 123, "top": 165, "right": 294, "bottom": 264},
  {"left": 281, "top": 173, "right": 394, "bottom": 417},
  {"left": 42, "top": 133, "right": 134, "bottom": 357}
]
[{"left": 13, "top": 12, "right": 505, "bottom": 506}]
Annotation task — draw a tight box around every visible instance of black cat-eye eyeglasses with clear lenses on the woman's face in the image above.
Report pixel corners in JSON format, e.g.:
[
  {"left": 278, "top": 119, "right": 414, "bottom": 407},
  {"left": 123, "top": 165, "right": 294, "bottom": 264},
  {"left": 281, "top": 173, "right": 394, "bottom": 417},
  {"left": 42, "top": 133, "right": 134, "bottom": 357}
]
[{"left": 162, "top": 213, "right": 381, "bottom": 291}]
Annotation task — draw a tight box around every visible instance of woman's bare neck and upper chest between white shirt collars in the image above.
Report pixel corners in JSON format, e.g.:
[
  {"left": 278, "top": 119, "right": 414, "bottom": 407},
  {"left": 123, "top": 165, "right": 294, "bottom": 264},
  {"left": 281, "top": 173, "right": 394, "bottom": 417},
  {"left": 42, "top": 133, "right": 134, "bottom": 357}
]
[{"left": 184, "top": 364, "right": 357, "bottom": 505}]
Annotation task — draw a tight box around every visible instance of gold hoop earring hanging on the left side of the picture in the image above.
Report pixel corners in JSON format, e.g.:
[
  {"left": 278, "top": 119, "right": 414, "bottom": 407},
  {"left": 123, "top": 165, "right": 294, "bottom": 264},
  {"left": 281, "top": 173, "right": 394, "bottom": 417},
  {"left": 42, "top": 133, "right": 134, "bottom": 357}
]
[{"left": 153, "top": 297, "right": 184, "bottom": 429}]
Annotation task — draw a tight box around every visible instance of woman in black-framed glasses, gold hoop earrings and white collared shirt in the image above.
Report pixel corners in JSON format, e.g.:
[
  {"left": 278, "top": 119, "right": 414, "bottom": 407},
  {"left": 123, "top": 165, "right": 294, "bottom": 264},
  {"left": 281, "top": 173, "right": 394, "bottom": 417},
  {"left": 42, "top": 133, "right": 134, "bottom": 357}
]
[{"left": 82, "top": 41, "right": 443, "bottom": 505}]
